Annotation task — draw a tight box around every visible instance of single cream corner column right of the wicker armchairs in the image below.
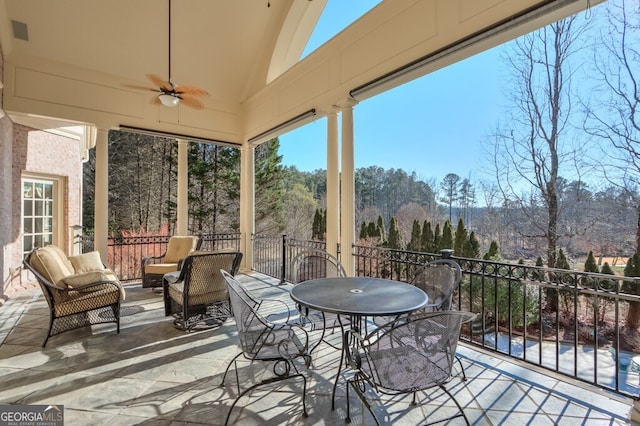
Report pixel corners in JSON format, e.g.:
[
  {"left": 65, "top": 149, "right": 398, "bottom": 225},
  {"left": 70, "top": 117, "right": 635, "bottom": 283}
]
[{"left": 240, "top": 145, "right": 256, "bottom": 271}]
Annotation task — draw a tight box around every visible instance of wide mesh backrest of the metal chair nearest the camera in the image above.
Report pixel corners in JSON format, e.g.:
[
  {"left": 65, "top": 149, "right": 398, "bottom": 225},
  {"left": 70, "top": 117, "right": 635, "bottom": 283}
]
[{"left": 358, "top": 311, "right": 475, "bottom": 393}]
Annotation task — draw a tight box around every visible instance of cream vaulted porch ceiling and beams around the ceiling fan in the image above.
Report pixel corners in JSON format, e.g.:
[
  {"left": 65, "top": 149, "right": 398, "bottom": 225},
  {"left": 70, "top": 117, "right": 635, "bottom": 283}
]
[{"left": 0, "top": 0, "right": 598, "bottom": 145}]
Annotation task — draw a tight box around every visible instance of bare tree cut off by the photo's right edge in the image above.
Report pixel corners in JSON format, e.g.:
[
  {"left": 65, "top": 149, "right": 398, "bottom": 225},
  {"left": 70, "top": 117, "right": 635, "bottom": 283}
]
[{"left": 585, "top": 1, "right": 640, "bottom": 329}]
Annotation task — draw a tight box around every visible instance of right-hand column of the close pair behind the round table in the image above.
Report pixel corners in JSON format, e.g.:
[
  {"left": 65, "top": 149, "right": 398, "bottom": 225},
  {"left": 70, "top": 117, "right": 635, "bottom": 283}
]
[{"left": 340, "top": 105, "right": 356, "bottom": 276}]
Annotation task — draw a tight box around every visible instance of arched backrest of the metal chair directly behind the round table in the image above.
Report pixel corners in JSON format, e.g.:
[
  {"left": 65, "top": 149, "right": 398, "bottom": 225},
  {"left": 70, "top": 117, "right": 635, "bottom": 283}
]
[{"left": 291, "top": 249, "right": 347, "bottom": 284}]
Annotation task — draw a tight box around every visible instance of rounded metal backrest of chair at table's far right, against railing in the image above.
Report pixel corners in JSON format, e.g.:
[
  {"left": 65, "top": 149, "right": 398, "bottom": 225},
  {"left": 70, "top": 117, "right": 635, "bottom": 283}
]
[{"left": 411, "top": 259, "right": 462, "bottom": 311}]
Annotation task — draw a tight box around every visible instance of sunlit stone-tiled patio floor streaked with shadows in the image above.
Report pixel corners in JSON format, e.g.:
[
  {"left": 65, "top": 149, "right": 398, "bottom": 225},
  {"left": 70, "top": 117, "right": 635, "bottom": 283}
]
[{"left": 0, "top": 273, "right": 638, "bottom": 425}]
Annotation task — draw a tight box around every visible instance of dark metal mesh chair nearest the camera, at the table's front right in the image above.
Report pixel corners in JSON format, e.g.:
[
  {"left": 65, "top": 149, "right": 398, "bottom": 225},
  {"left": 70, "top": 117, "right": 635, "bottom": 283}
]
[{"left": 346, "top": 311, "right": 475, "bottom": 425}]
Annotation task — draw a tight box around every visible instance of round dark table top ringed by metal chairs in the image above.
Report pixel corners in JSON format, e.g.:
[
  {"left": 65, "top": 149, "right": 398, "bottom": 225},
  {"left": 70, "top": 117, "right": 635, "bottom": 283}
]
[{"left": 291, "top": 277, "right": 429, "bottom": 316}]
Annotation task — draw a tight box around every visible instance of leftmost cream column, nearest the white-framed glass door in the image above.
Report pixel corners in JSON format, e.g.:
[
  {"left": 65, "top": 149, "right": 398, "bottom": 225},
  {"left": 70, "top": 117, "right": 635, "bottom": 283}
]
[{"left": 93, "top": 129, "right": 108, "bottom": 267}]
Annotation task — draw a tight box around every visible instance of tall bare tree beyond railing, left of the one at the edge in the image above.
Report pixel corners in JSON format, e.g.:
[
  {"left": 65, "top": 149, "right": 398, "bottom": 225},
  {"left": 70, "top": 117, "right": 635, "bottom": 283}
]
[{"left": 494, "top": 16, "right": 583, "bottom": 272}]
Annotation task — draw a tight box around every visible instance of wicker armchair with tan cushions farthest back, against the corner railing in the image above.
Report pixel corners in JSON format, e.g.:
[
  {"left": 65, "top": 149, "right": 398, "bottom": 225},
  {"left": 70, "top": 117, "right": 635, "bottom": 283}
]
[{"left": 142, "top": 236, "right": 202, "bottom": 288}]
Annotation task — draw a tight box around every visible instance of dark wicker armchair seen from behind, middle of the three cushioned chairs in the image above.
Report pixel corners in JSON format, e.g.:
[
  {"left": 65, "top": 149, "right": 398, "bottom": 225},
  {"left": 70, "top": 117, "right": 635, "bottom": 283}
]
[{"left": 163, "top": 252, "right": 242, "bottom": 331}]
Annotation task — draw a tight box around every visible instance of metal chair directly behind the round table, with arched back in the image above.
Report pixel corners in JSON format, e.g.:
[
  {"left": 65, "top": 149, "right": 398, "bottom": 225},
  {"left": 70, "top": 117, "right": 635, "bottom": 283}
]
[{"left": 291, "top": 249, "right": 347, "bottom": 352}]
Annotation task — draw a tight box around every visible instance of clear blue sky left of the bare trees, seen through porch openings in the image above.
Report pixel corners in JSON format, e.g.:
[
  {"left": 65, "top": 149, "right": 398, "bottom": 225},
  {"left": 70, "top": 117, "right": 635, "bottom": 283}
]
[{"left": 280, "top": 0, "right": 505, "bottom": 183}]
